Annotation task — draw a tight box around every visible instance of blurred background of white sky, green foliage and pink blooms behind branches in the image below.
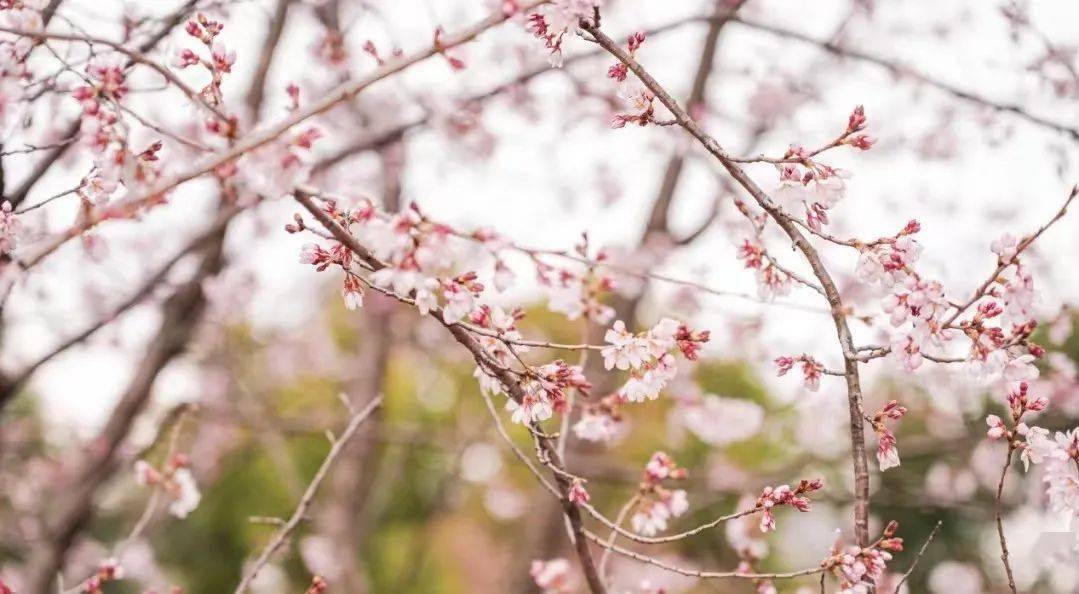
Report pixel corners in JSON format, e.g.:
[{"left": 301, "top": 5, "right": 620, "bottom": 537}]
[{"left": 0, "top": 0, "right": 1079, "bottom": 594}]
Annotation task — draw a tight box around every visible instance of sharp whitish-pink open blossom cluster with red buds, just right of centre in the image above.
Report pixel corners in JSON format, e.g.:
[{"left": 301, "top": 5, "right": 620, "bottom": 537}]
[{"left": 600, "top": 318, "right": 709, "bottom": 402}]
